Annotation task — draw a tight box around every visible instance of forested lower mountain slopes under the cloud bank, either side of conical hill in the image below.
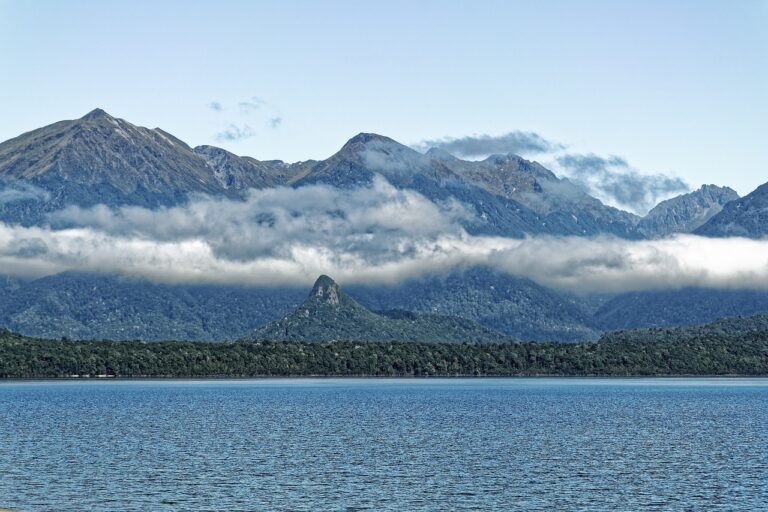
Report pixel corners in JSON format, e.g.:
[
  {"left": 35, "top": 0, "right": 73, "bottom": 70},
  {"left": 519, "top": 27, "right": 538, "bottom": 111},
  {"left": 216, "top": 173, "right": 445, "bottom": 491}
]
[{"left": 0, "top": 268, "right": 768, "bottom": 342}]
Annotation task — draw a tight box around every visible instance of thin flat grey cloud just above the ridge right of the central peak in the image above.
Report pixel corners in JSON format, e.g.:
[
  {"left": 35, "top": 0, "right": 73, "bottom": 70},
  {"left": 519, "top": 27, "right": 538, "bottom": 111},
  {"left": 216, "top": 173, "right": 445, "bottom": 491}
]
[{"left": 415, "top": 131, "right": 564, "bottom": 157}]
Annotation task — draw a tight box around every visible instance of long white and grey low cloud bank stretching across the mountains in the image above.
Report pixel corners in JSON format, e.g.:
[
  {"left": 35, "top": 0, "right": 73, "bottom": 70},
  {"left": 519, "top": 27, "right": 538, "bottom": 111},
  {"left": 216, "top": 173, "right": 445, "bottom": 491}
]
[{"left": 0, "top": 179, "right": 768, "bottom": 292}]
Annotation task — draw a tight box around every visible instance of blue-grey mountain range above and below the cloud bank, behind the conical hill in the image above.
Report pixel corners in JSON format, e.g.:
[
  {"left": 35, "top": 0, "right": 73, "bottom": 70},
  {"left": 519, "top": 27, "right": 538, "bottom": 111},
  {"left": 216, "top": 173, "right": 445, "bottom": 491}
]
[{"left": 0, "top": 109, "right": 768, "bottom": 341}]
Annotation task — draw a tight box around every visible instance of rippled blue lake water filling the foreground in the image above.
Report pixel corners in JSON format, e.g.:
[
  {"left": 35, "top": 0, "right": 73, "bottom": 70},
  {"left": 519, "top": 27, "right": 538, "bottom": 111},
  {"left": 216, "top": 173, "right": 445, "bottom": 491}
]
[{"left": 0, "top": 379, "right": 768, "bottom": 511}]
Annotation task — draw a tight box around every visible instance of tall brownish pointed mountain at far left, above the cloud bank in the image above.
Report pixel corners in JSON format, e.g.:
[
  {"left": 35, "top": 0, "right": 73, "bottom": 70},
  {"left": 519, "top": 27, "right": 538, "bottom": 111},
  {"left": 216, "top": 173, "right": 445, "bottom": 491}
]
[{"left": 0, "top": 109, "right": 221, "bottom": 223}]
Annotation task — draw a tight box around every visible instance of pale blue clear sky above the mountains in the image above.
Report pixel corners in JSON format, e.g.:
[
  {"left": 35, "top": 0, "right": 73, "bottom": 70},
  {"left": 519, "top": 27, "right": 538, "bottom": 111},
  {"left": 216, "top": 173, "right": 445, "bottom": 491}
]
[{"left": 0, "top": 0, "right": 768, "bottom": 194}]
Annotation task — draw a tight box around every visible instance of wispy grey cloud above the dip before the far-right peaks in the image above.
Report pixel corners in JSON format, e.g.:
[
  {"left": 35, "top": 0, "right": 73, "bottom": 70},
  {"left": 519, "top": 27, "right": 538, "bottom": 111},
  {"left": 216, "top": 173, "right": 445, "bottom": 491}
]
[{"left": 556, "top": 153, "right": 690, "bottom": 215}]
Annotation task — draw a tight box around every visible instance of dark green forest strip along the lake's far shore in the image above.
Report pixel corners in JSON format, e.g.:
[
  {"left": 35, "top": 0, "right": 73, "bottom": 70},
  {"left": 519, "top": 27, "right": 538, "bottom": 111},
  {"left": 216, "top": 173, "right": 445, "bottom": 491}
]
[{"left": 0, "top": 331, "right": 768, "bottom": 378}]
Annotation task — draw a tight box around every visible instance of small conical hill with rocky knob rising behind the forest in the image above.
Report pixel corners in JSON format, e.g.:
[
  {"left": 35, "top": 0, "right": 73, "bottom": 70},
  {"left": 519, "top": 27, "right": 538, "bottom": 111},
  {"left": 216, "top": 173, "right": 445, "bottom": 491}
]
[{"left": 248, "top": 276, "right": 513, "bottom": 343}]
